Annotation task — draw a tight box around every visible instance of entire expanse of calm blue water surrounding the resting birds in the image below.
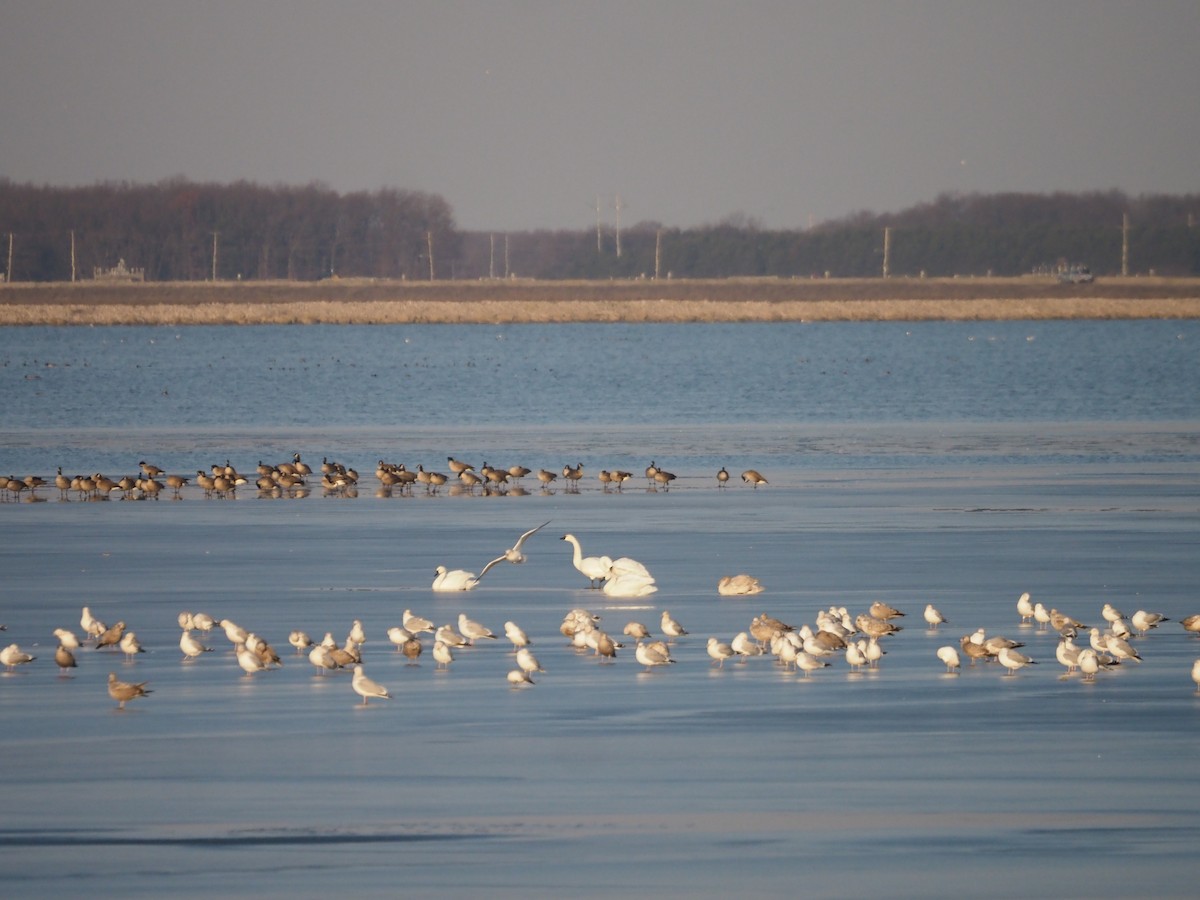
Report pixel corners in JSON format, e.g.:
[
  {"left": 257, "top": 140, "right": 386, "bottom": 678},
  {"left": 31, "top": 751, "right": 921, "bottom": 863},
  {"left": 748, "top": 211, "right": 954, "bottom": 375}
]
[{"left": 0, "top": 322, "right": 1200, "bottom": 898}]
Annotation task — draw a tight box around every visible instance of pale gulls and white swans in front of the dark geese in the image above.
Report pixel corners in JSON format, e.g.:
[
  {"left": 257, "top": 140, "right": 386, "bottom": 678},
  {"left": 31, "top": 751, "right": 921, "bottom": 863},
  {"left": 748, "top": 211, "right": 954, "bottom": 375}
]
[{"left": 0, "top": 566, "right": 1200, "bottom": 709}]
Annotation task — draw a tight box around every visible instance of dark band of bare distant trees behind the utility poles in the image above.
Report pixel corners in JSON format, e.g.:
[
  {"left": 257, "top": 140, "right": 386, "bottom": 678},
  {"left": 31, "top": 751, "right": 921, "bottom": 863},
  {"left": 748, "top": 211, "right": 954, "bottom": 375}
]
[{"left": 0, "top": 179, "right": 1200, "bottom": 281}]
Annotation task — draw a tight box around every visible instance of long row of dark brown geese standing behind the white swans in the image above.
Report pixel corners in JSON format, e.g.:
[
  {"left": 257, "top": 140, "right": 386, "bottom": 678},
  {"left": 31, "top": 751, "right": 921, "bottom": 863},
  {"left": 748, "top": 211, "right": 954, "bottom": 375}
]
[{"left": 0, "top": 454, "right": 768, "bottom": 502}]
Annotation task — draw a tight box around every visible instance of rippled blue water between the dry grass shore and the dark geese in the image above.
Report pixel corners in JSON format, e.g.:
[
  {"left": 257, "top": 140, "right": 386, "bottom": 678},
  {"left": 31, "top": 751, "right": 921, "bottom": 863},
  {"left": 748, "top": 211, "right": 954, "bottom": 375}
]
[{"left": 0, "top": 320, "right": 1200, "bottom": 473}]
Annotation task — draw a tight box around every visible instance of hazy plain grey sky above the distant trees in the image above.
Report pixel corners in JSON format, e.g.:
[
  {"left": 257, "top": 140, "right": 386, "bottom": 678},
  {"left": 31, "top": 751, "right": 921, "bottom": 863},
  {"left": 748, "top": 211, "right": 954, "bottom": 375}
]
[{"left": 0, "top": 0, "right": 1200, "bottom": 232}]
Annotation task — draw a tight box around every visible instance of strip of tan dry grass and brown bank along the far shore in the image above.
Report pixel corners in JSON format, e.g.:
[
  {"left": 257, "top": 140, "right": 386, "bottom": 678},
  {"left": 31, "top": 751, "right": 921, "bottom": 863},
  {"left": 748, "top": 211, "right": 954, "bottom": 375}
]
[{"left": 0, "top": 277, "right": 1200, "bottom": 325}]
